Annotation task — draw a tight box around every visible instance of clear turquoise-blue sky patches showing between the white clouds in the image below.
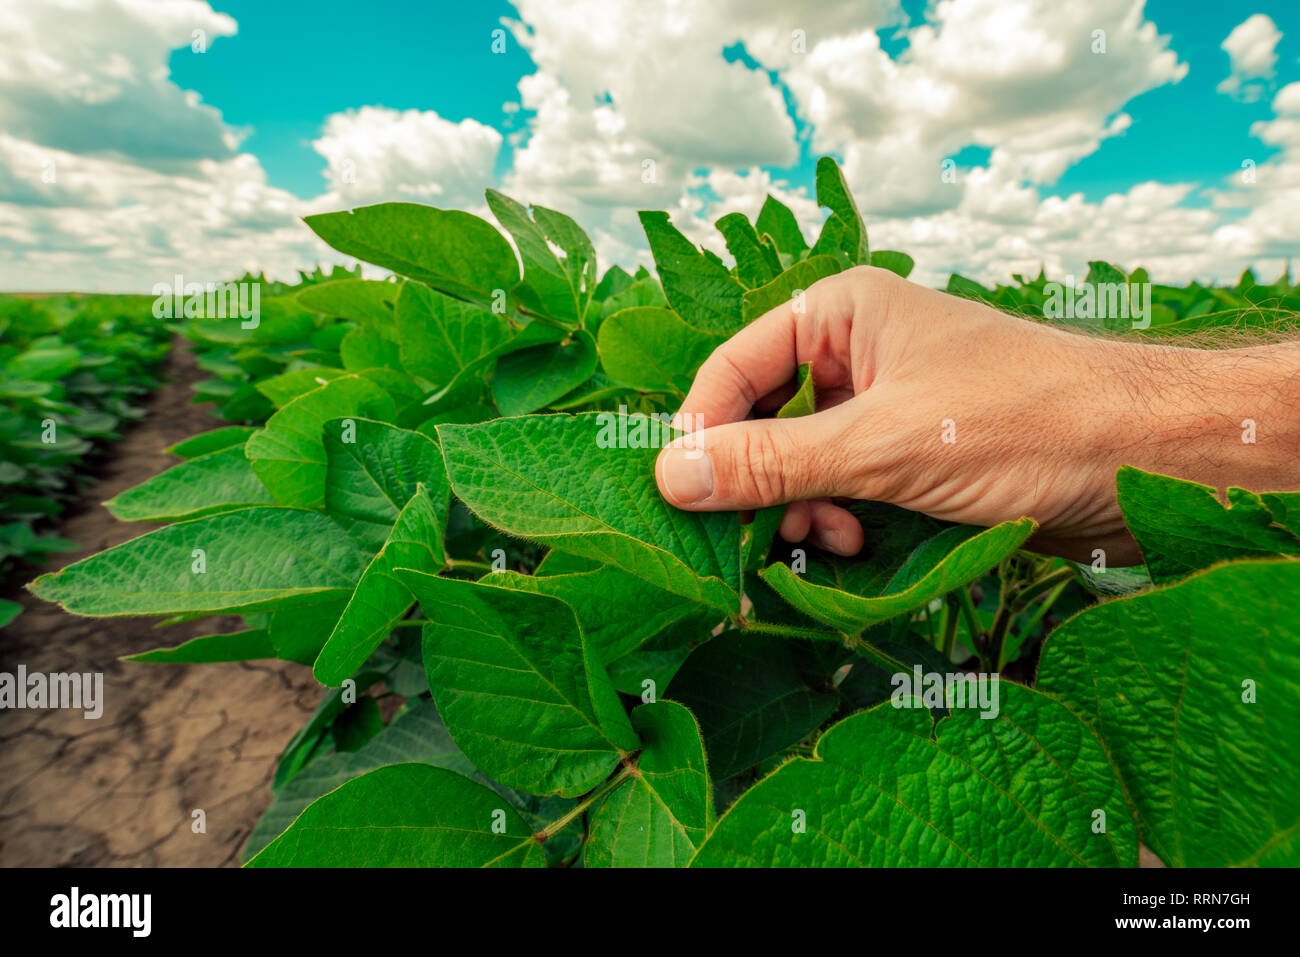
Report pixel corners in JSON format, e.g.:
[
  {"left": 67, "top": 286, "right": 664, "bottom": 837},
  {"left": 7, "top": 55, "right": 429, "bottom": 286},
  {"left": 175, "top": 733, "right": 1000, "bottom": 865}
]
[{"left": 169, "top": 0, "right": 1300, "bottom": 205}]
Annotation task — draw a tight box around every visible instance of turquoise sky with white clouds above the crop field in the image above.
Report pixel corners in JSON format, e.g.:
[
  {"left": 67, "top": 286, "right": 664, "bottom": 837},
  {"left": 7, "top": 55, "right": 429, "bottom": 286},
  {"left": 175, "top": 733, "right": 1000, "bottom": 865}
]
[{"left": 0, "top": 0, "right": 1300, "bottom": 291}]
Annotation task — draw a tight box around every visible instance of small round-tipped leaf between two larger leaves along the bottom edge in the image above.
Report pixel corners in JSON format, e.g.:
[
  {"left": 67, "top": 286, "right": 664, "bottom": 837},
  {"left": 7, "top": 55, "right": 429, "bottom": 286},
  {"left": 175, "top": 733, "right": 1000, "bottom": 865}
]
[{"left": 582, "top": 701, "right": 712, "bottom": 867}]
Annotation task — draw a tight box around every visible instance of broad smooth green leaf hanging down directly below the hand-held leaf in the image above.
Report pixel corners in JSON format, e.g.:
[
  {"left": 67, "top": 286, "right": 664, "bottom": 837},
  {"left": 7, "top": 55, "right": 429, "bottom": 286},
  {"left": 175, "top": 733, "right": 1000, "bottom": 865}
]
[{"left": 400, "top": 570, "right": 637, "bottom": 797}]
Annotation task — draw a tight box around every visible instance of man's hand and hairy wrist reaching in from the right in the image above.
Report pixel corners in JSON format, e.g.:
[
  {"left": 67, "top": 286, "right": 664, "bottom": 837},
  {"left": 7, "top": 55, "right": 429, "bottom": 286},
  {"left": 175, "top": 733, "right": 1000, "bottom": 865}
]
[{"left": 655, "top": 267, "right": 1300, "bottom": 564}]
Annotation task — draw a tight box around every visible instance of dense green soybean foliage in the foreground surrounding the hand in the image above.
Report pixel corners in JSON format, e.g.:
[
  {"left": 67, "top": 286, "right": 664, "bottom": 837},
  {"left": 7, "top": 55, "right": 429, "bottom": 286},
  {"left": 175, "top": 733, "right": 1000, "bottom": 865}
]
[{"left": 27, "top": 159, "right": 1300, "bottom": 867}]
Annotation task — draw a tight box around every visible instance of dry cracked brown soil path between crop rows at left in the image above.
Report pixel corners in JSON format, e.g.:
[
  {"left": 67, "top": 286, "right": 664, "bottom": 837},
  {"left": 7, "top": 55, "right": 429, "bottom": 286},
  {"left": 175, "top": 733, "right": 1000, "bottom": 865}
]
[{"left": 0, "top": 347, "right": 320, "bottom": 867}]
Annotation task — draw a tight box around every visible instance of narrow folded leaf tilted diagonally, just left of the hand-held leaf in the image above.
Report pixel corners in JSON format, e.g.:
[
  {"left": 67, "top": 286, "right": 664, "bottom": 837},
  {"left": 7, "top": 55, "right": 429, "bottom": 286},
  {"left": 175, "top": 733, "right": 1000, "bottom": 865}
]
[{"left": 312, "top": 485, "right": 447, "bottom": 685}]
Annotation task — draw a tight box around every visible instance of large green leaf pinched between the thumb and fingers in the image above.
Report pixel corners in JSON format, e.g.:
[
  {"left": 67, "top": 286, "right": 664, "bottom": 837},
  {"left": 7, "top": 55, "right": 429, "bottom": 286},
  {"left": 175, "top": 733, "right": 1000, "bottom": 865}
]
[{"left": 438, "top": 413, "right": 740, "bottom": 611}]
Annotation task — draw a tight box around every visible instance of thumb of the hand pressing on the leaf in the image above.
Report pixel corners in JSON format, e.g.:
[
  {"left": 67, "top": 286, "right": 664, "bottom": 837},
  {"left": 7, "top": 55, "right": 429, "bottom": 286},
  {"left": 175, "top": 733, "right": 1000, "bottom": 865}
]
[{"left": 655, "top": 403, "right": 852, "bottom": 511}]
